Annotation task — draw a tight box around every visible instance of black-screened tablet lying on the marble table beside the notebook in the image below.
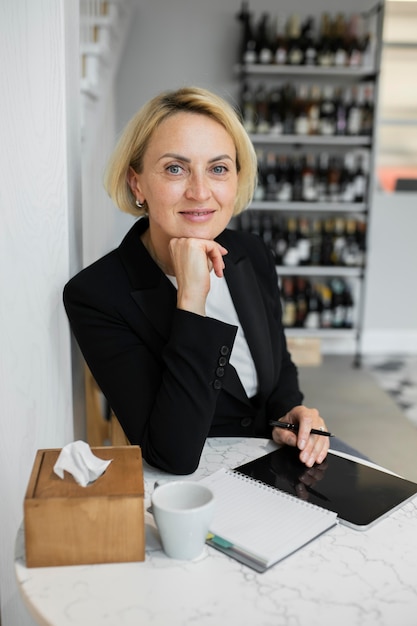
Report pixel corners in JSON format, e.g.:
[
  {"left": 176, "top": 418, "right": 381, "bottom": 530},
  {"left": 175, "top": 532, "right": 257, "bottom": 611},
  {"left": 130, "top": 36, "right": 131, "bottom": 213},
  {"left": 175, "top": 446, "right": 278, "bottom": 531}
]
[{"left": 235, "top": 446, "right": 417, "bottom": 530}]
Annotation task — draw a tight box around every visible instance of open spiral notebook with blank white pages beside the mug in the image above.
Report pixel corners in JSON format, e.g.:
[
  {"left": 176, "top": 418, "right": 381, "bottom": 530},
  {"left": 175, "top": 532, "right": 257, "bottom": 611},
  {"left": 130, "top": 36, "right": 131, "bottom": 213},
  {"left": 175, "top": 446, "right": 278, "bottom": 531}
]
[{"left": 197, "top": 468, "right": 337, "bottom": 572}]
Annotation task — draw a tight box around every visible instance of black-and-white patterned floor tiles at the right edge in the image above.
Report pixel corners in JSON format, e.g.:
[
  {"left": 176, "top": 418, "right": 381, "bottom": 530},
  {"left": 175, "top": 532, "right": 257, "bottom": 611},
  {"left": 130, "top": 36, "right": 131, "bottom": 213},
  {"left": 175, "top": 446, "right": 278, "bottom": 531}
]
[{"left": 363, "top": 356, "right": 417, "bottom": 432}]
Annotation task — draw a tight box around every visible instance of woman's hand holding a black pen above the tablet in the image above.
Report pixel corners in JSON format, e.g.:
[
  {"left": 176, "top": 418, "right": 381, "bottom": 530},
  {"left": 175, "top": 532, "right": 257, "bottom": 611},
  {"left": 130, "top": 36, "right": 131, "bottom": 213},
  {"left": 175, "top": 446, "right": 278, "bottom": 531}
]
[{"left": 272, "top": 405, "right": 329, "bottom": 467}]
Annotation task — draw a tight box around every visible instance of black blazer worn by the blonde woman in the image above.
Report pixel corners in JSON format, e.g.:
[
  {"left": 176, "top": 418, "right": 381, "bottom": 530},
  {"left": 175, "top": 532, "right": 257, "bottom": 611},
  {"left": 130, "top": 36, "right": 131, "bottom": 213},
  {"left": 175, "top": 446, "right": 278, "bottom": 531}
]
[{"left": 64, "top": 218, "right": 303, "bottom": 474}]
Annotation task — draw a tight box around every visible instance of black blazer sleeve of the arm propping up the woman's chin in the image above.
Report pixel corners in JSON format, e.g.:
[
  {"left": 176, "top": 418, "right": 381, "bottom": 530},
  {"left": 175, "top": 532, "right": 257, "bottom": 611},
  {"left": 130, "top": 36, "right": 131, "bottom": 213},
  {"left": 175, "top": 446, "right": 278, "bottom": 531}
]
[{"left": 64, "top": 262, "right": 237, "bottom": 474}]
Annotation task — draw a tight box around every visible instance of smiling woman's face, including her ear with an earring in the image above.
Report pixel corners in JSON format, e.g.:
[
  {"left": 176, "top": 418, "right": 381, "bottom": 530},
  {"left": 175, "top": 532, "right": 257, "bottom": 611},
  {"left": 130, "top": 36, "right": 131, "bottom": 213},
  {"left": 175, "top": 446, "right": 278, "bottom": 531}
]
[{"left": 130, "top": 112, "right": 238, "bottom": 245}]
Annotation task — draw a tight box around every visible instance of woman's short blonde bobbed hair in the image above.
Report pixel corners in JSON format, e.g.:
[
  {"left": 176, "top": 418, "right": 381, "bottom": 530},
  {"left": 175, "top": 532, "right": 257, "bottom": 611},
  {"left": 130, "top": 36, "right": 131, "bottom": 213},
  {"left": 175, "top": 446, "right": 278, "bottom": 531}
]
[{"left": 104, "top": 87, "right": 257, "bottom": 217}]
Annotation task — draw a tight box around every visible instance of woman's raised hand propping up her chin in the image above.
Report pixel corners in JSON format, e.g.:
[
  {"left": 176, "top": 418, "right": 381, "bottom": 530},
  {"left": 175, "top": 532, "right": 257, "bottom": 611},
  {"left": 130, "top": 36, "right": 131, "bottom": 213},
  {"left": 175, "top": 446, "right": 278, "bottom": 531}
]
[{"left": 169, "top": 237, "right": 227, "bottom": 315}]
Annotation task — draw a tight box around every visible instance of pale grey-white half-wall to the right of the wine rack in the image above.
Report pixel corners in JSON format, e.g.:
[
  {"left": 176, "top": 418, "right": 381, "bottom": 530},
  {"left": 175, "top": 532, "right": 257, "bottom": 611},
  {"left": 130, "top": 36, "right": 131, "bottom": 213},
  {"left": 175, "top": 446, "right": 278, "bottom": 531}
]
[{"left": 363, "top": 192, "right": 417, "bottom": 354}]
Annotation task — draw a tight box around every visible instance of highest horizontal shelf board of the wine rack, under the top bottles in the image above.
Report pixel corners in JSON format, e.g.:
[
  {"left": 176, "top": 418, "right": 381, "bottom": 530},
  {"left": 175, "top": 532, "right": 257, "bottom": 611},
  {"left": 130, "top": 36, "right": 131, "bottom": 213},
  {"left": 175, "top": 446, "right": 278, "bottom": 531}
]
[{"left": 238, "top": 63, "right": 375, "bottom": 80}]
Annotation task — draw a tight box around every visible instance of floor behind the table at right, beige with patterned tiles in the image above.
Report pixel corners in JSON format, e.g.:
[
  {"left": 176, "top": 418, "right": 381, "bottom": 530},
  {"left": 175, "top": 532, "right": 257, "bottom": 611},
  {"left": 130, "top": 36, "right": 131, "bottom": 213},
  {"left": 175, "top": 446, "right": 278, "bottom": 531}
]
[{"left": 299, "top": 355, "right": 417, "bottom": 482}]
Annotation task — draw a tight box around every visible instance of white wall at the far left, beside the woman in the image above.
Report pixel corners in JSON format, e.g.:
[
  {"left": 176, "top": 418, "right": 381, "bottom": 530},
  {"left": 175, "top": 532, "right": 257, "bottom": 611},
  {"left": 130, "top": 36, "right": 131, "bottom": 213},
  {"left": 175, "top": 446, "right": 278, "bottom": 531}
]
[{"left": 0, "top": 0, "right": 81, "bottom": 626}]
